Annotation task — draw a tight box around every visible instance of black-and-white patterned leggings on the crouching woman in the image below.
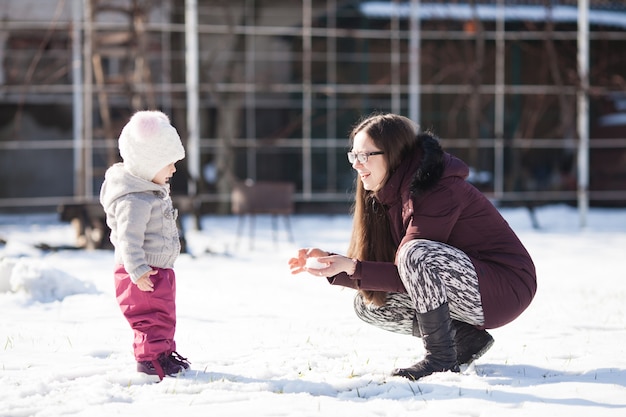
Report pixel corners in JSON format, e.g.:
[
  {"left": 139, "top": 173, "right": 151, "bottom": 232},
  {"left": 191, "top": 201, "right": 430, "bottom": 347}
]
[{"left": 354, "top": 240, "right": 485, "bottom": 334}]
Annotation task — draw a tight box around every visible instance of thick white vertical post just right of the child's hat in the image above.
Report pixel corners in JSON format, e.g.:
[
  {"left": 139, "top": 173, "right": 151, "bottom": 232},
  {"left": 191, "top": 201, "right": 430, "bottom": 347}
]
[{"left": 185, "top": 0, "right": 200, "bottom": 196}]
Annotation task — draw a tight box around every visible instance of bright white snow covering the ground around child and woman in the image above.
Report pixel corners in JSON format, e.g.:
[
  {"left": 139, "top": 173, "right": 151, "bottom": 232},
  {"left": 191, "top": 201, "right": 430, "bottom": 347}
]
[{"left": 0, "top": 206, "right": 626, "bottom": 417}]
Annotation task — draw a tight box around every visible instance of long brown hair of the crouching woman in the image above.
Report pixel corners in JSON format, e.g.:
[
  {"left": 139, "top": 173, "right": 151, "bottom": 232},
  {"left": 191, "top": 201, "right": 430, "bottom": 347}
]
[{"left": 347, "top": 114, "right": 418, "bottom": 306}]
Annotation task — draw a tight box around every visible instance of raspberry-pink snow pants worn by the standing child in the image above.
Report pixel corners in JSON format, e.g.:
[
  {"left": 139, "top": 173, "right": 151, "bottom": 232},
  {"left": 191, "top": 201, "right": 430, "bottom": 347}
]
[{"left": 115, "top": 265, "right": 176, "bottom": 361}]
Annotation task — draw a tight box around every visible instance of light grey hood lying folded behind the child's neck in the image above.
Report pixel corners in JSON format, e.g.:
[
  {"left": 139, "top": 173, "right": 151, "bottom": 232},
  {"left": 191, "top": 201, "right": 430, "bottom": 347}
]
[{"left": 100, "top": 162, "right": 169, "bottom": 211}]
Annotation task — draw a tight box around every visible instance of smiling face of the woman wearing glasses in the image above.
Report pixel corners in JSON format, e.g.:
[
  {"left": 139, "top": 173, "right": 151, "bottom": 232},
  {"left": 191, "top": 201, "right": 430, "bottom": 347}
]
[{"left": 352, "top": 131, "right": 387, "bottom": 191}]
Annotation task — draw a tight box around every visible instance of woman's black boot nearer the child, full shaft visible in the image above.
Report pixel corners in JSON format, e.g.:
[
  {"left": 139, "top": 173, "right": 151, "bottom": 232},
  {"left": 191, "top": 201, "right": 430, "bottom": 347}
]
[{"left": 393, "top": 303, "right": 459, "bottom": 380}]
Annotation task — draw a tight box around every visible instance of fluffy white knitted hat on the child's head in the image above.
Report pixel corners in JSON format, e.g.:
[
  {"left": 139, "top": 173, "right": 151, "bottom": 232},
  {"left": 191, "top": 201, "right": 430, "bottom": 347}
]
[{"left": 119, "top": 111, "right": 185, "bottom": 181}]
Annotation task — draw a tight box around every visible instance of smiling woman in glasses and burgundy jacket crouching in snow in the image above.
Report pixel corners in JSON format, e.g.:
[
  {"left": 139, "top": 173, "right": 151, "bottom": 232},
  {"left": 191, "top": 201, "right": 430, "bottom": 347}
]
[{"left": 289, "top": 114, "right": 537, "bottom": 379}]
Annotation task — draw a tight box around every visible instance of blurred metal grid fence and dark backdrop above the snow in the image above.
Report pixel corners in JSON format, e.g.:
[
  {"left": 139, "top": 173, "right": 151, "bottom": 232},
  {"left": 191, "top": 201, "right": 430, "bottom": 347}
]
[{"left": 0, "top": 0, "right": 626, "bottom": 217}]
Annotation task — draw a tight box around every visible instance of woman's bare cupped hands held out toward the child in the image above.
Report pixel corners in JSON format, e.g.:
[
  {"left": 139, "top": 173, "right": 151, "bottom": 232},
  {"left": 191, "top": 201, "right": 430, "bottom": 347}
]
[{"left": 289, "top": 248, "right": 356, "bottom": 277}]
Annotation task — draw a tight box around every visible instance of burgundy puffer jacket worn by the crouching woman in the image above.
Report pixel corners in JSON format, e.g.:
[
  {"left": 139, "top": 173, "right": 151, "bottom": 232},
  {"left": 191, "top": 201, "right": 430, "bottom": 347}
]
[{"left": 329, "top": 139, "right": 537, "bottom": 329}]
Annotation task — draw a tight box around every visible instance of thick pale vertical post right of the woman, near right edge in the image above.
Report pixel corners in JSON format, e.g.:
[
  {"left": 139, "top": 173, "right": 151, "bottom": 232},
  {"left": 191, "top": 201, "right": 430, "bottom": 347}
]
[{"left": 577, "top": 0, "right": 589, "bottom": 228}]
